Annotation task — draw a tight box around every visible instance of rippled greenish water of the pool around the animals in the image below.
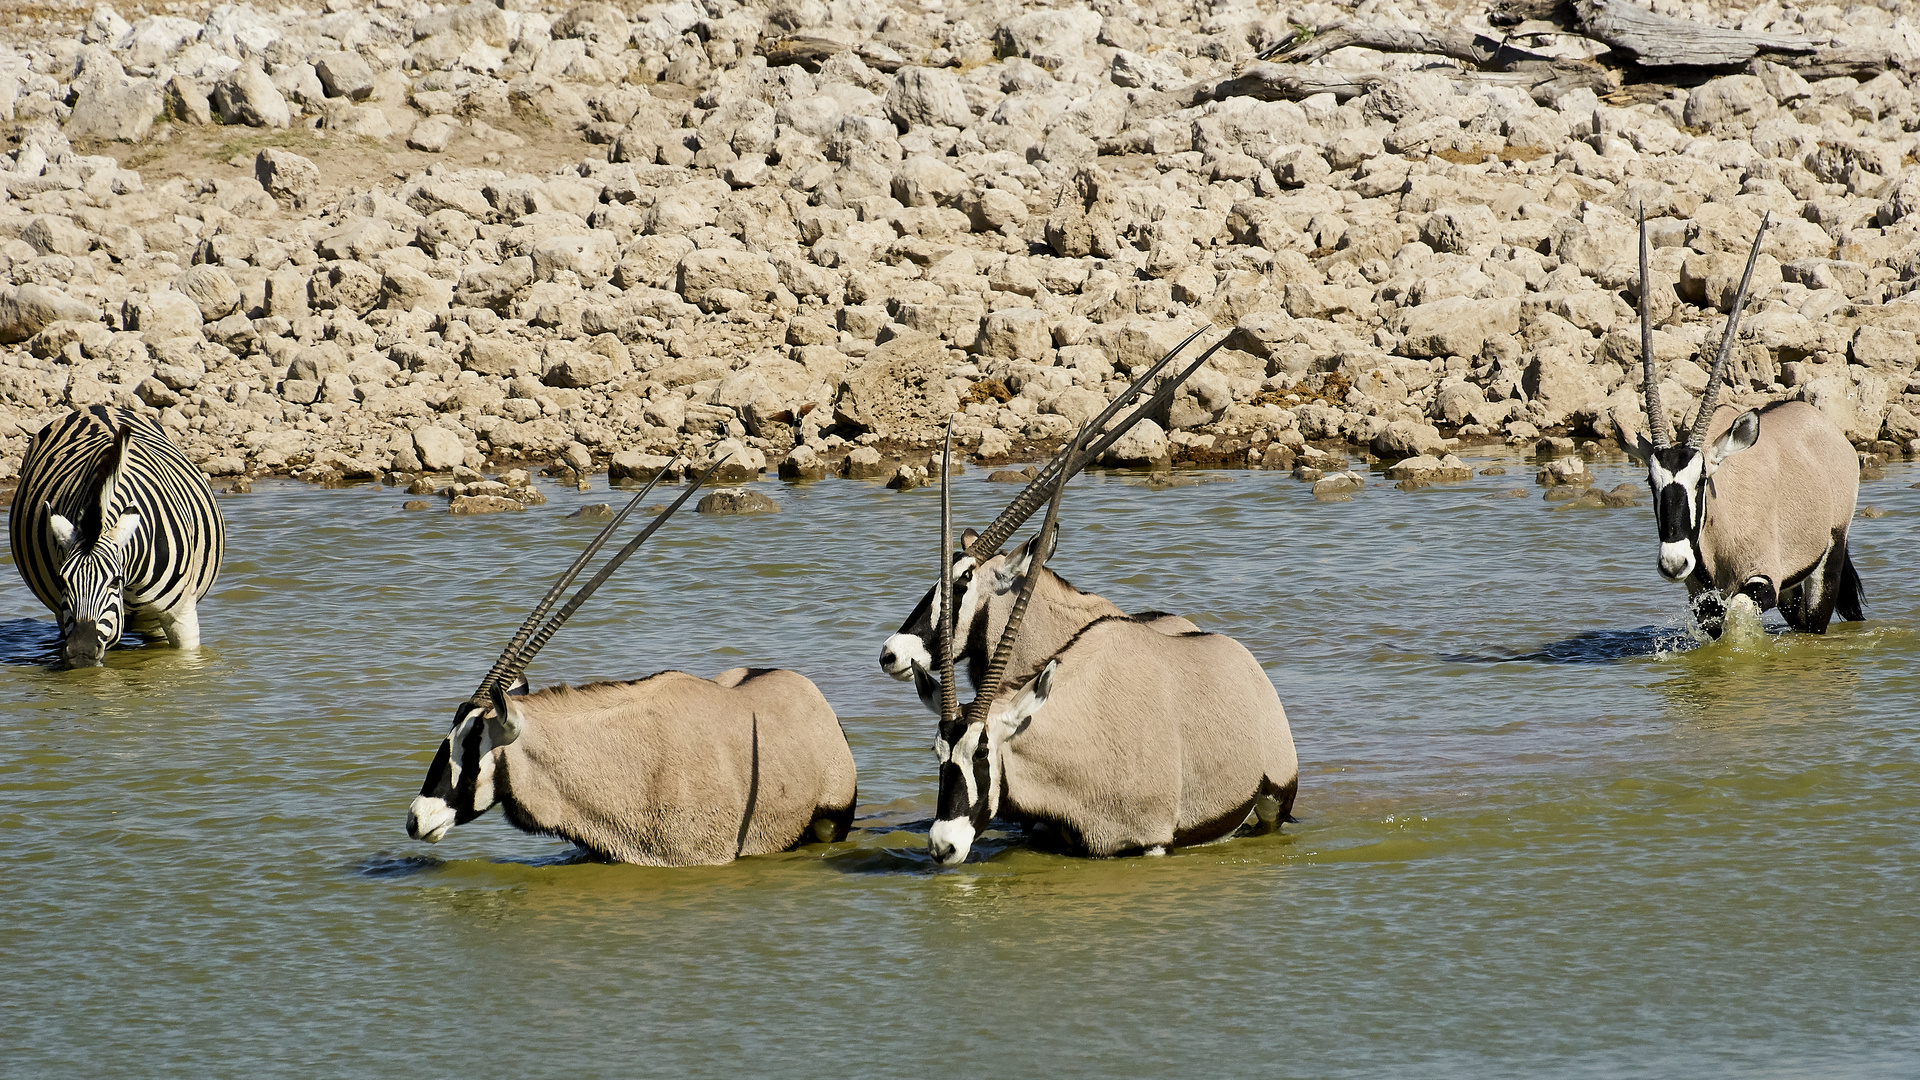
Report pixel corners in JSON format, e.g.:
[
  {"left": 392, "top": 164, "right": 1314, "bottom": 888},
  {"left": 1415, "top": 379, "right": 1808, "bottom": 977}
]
[{"left": 0, "top": 447, "right": 1920, "bottom": 1078}]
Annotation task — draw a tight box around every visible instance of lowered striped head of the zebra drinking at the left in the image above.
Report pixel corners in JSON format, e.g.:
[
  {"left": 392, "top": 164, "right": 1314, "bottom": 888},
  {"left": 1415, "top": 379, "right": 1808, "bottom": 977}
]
[{"left": 44, "top": 430, "right": 142, "bottom": 667}]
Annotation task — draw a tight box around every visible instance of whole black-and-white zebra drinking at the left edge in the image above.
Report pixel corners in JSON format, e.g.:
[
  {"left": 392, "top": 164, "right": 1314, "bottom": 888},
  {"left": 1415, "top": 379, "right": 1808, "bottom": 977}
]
[{"left": 8, "top": 405, "right": 227, "bottom": 667}]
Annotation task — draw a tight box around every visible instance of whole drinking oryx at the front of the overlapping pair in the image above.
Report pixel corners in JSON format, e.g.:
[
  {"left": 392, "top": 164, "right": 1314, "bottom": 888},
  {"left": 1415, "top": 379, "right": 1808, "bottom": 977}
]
[{"left": 916, "top": 418, "right": 1300, "bottom": 865}]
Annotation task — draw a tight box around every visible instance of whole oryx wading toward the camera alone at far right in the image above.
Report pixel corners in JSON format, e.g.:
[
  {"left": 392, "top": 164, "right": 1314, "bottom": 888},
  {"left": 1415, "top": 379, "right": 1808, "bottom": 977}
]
[{"left": 1620, "top": 215, "right": 1866, "bottom": 636}]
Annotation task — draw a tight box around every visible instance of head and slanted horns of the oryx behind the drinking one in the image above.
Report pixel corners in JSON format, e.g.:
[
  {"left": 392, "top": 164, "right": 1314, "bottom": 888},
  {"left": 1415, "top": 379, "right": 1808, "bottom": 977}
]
[{"left": 879, "top": 331, "right": 1225, "bottom": 682}]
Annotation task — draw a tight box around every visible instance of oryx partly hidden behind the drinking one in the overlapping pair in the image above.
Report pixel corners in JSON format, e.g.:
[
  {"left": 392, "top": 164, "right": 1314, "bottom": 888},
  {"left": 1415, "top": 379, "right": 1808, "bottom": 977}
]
[{"left": 879, "top": 331, "right": 1225, "bottom": 713}]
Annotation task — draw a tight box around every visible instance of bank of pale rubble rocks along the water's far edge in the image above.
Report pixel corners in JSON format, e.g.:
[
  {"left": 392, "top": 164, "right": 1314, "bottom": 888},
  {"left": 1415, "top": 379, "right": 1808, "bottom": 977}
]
[{"left": 0, "top": 0, "right": 1920, "bottom": 511}]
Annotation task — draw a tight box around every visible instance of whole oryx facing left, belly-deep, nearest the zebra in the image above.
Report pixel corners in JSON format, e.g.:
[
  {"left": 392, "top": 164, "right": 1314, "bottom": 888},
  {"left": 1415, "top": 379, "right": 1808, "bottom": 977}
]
[{"left": 407, "top": 457, "right": 854, "bottom": 867}]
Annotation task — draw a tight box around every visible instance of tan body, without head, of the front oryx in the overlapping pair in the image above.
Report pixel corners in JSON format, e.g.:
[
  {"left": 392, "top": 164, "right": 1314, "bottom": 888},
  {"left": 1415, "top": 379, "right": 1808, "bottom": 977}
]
[{"left": 989, "top": 617, "right": 1300, "bottom": 855}]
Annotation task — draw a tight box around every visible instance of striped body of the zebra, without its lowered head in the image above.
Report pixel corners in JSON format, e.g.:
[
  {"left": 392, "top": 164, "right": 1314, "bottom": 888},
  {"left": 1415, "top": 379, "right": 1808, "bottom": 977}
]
[{"left": 8, "top": 405, "right": 227, "bottom": 644}]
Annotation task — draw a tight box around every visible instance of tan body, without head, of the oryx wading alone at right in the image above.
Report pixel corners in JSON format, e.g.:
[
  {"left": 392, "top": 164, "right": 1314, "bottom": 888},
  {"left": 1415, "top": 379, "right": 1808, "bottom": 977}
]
[{"left": 1688, "top": 402, "right": 1860, "bottom": 628}]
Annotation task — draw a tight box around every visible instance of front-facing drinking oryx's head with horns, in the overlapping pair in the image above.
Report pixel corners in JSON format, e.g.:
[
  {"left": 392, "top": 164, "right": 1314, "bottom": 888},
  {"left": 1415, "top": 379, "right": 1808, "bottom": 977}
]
[{"left": 929, "top": 423, "right": 1092, "bottom": 867}]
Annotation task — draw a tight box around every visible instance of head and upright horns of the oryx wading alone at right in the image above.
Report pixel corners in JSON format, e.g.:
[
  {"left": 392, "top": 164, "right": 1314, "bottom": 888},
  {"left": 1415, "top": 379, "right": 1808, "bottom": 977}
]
[{"left": 1620, "top": 209, "right": 1768, "bottom": 580}]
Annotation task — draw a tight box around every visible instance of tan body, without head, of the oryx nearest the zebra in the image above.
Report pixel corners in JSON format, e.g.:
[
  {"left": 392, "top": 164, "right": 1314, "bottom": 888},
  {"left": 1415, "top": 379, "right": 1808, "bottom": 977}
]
[{"left": 493, "top": 667, "right": 854, "bottom": 867}]
